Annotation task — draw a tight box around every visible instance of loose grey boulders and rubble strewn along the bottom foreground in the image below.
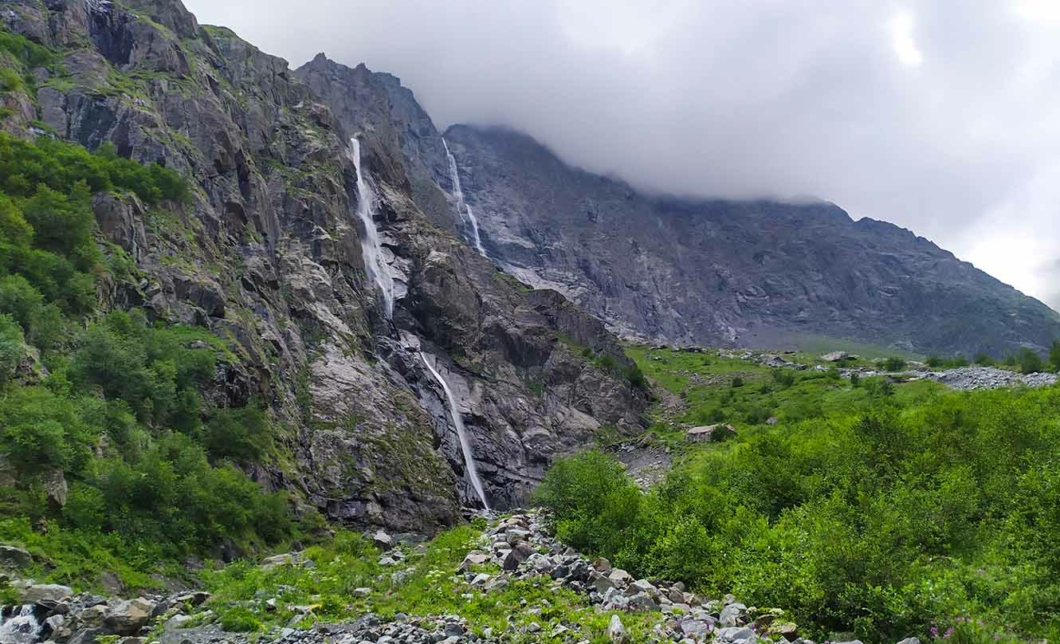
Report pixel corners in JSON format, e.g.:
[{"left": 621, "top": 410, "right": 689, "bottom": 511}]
[{"left": 0, "top": 514, "right": 928, "bottom": 644}]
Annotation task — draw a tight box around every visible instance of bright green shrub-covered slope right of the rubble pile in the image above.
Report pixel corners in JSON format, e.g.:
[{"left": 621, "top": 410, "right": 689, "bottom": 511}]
[{"left": 538, "top": 351, "right": 1060, "bottom": 641}]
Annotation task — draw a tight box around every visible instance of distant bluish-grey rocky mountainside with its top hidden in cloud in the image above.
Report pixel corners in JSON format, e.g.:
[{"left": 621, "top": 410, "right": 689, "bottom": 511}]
[{"left": 434, "top": 126, "right": 1060, "bottom": 355}]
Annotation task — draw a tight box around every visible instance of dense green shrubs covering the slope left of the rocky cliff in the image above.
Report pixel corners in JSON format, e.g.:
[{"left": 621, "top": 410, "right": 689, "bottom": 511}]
[{"left": 0, "top": 133, "right": 292, "bottom": 586}]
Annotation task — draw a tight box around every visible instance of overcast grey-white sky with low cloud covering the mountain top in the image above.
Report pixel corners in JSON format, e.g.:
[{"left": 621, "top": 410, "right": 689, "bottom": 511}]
[{"left": 184, "top": 0, "right": 1060, "bottom": 307}]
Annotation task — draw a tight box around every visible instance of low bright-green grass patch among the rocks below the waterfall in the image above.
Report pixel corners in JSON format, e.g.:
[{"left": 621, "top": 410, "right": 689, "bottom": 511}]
[{"left": 205, "top": 525, "right": 652, "bottom": 643}]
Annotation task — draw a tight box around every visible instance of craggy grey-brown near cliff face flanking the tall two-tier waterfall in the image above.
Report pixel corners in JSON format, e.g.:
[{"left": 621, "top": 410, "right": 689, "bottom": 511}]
[{"left": 0, "top": 0, "right": 647, "bottom": 530}]
